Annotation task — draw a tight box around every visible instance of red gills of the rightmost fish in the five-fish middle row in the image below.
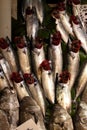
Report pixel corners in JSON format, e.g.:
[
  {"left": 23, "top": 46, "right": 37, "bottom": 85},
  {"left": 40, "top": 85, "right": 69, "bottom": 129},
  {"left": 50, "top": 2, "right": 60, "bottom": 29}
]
[{"left": 71, "top": 40, "right": 81, "bottom": 53}]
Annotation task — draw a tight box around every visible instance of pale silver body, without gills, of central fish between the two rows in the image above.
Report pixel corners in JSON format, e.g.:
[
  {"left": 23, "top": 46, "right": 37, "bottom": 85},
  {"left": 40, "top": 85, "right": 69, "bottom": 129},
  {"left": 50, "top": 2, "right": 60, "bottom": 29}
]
[{"left": 41, "top": 69, "right": 55, "bottom": 103}]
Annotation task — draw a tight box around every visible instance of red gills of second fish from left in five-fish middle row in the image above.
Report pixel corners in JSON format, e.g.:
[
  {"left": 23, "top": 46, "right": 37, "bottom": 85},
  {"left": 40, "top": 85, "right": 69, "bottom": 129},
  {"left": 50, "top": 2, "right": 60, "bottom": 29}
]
[{"left": 14, "top": 36, "right": 26, "bottom": 49}]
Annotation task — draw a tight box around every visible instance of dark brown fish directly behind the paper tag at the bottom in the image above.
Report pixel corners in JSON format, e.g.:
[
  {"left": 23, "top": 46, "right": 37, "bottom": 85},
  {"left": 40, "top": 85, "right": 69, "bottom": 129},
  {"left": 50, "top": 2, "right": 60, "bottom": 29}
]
[{"left": 19, "top": 96, "right": 46, "bottom": 130}]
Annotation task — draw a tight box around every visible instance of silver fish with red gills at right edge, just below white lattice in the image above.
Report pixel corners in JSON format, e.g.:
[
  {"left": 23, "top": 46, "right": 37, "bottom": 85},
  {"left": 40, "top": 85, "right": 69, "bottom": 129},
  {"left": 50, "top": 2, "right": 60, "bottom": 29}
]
[{"left": 71, "top": 15, "right": 87, "bottom": 54}]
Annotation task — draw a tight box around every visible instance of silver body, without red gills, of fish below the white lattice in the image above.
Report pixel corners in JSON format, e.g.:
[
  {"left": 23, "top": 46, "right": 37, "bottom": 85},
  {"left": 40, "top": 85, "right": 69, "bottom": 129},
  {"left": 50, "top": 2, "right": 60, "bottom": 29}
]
[{"left": 72, "top": 17, "right": 87, "bottom": 54}]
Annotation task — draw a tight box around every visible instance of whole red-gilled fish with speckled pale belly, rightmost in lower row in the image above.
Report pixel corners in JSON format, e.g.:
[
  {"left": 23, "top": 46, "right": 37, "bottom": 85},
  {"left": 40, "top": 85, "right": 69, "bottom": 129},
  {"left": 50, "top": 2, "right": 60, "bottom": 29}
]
[{"left": 55, "top": 70, "right": 72, "bottom": 113}]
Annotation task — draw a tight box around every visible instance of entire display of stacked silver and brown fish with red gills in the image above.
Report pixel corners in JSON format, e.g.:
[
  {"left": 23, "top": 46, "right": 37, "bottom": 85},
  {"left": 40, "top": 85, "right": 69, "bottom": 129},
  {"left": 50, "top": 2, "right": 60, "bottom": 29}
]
[{"left": 0, "top": 0, "right": 87, "bottom": 130}]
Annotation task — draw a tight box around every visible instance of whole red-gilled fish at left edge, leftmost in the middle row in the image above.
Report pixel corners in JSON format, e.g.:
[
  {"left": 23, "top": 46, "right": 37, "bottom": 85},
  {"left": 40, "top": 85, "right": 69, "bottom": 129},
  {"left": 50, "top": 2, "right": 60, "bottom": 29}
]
[{"left": 0, "top": 38, "right": 18, "bottom": 72}]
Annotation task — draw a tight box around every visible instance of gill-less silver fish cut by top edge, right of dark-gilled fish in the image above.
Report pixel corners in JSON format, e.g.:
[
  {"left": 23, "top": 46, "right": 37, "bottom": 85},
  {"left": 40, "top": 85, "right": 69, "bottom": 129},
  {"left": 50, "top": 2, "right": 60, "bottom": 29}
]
[{"left": 34, "top": 0, "right": 44, "bottom": 25}]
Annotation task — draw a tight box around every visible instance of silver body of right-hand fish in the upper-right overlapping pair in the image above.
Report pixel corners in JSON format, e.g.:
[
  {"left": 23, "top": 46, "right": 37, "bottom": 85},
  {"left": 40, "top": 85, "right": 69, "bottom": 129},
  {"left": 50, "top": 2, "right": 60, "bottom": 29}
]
[{"left": 59, "top": 11, "right": 74, "bottom": 36}]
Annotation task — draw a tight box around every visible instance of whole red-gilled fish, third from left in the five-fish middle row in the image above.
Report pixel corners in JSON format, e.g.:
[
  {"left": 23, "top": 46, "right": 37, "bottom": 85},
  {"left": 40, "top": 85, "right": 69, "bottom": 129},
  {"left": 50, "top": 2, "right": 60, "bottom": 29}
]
[{"left": 32, "top": 38, "right": 45, "bottom": 82}]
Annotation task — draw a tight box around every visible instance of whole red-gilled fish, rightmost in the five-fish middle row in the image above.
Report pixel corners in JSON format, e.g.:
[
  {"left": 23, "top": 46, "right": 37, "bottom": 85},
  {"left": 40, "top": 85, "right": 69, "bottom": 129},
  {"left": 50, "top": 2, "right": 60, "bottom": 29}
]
[{"left": 67, "top": 40, "right": 81, "bottom": 90}]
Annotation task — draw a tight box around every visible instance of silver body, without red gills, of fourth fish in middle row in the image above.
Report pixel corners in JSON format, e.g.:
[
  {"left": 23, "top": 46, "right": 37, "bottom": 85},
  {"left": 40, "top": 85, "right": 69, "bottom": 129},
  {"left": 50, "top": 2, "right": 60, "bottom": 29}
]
[{"left": 49, "top": 43, "right": 63, "bottom": 81}]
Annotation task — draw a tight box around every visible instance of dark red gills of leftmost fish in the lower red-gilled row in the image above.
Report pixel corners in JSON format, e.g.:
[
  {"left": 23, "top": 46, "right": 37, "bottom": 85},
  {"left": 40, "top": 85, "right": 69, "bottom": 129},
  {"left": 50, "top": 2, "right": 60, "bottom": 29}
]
[{"left": 10, "top": 72, "right": 23, "bottom": 83}]
